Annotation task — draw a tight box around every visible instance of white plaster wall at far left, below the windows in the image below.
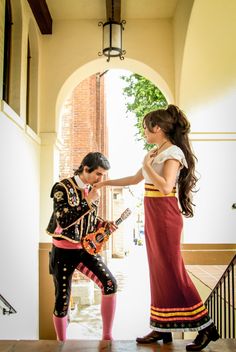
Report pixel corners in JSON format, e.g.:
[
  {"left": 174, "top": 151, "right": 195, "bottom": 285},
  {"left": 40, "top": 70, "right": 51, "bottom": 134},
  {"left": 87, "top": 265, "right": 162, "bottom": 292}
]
[{"left": 0, "top": 109, "right": 40, "bottom": 339}]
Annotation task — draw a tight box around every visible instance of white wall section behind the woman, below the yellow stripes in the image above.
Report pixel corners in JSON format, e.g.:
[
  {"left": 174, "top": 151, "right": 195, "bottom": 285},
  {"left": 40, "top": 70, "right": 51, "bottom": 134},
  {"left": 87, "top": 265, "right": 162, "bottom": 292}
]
[{"left": 183, "top": 140, "right": 236, "bottom": 243}]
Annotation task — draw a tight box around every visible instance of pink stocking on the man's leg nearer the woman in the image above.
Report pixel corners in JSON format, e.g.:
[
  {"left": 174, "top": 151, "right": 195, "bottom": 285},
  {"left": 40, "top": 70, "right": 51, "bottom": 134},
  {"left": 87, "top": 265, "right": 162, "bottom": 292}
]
[{"left": 101, "top": 294, "right": 116, "bottom": 340}]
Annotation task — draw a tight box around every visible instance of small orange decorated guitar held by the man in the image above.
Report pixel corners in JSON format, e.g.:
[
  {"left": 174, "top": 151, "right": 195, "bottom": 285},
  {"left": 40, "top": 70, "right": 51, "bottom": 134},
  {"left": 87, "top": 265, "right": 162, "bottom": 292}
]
[{"left": 82, "top": 208, "right": 131, "bottom": 255}]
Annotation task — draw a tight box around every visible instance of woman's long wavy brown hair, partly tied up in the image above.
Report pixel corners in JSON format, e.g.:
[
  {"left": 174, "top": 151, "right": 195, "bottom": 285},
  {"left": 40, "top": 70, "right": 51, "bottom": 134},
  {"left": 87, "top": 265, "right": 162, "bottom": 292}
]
[{"left": 143, "top": 104, "right": 198, "bottom": 217}]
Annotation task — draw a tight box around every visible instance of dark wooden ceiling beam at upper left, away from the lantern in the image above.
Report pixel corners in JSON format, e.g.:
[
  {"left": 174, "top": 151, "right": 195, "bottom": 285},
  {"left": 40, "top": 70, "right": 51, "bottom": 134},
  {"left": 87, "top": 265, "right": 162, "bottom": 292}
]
[{"left": 28, "top": 0, "right": 52, "bottom": 34}]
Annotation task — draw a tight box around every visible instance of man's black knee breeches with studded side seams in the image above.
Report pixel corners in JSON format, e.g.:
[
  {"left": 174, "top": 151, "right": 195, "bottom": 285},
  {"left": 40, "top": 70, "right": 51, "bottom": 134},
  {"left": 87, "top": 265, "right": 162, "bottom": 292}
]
[{"left": 49, "top": 246, "right": 117, "bottom": 317}]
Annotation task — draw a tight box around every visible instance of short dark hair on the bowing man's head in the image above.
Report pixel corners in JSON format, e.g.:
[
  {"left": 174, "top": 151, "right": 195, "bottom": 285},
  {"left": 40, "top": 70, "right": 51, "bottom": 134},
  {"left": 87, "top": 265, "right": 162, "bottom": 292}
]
[{"left": 74, "top": 152, "right": 110, "bottom": 175}]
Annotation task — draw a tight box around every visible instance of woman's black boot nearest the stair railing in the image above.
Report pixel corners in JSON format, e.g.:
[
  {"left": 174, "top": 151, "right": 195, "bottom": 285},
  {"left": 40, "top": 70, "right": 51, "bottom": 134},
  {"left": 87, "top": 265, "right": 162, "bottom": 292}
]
[{"left": 186, "top": 324, "right": 220, "bottom": 351}]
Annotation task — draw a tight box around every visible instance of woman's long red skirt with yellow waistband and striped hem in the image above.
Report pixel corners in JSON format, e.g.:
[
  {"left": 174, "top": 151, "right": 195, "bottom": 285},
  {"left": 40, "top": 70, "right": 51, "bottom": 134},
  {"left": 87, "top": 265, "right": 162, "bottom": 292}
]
[{"left": 144, "top": 184, "right": 212, "bottom": 332}]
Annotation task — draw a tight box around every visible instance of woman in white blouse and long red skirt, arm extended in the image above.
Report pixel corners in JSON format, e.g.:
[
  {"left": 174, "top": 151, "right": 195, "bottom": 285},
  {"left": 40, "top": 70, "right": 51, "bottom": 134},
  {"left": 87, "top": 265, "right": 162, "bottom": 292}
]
[{"left": 95, "top": 105, "right": 219, "bottom": 351}]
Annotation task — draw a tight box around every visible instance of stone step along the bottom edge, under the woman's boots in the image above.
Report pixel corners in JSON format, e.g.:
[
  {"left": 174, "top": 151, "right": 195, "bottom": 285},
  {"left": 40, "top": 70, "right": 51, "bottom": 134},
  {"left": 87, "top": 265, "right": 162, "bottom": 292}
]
[{"left": 0, "top": 339, "right": 236, "bottom": 352}]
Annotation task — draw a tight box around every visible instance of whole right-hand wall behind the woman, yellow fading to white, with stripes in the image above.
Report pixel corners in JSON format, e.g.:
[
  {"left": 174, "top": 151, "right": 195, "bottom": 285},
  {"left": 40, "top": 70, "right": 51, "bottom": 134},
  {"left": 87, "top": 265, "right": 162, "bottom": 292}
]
[{"left": 178, "top": 0, "right": 236, "bottom": 243}]
